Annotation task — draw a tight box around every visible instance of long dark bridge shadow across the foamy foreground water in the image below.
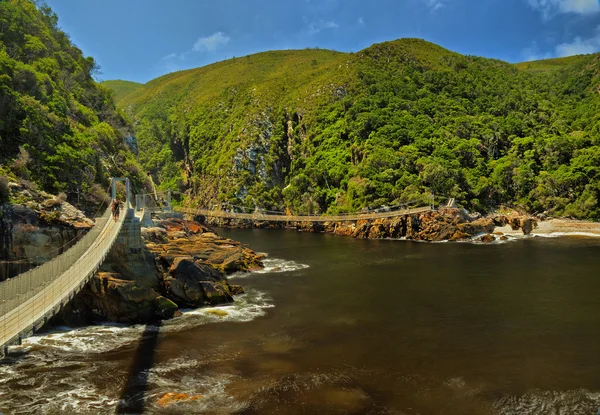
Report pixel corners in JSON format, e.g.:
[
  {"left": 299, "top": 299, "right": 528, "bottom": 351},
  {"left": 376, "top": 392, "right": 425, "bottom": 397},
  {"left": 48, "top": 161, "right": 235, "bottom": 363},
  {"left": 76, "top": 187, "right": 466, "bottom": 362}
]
[{"left": 116, "top": 323, "right": 161, "bottom": 414}]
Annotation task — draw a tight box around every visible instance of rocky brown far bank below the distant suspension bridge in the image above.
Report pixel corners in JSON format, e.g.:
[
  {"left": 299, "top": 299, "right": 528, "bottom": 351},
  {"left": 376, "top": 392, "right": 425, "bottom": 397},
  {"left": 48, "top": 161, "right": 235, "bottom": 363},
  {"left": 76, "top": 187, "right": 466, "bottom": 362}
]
[{"left": 193, "top": 208, "right": 539, "bottom": 242}]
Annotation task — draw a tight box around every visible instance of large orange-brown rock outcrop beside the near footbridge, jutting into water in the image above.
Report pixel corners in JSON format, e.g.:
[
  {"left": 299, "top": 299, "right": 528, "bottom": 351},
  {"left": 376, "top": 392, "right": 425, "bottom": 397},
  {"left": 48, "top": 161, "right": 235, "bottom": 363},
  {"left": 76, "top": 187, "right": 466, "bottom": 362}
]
[{"left": 52, "top": 219, "right": 263, "bottom": 326}]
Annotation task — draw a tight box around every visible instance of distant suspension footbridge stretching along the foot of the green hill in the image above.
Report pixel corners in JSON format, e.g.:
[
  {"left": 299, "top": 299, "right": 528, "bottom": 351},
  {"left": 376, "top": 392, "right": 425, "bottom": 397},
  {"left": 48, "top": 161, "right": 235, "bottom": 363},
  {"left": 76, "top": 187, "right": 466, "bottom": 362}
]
[{"left": 175, "top": 206, "right": 431, "bottom": 222}]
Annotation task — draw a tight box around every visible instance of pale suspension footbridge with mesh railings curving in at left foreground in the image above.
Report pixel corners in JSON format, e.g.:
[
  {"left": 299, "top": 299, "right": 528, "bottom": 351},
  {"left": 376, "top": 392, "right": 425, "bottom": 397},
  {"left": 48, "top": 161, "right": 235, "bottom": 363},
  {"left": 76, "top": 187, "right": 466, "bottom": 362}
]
[{"left": 0, "top": 209, "right": 127, "bottom": 354}]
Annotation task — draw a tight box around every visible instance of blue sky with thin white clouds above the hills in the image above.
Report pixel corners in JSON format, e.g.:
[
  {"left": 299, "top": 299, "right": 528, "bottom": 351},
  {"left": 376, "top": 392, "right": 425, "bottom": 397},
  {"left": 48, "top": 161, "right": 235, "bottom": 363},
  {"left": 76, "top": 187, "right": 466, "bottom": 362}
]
[{"left": 46, "top": 0, "right": 600, "bottom": 83}]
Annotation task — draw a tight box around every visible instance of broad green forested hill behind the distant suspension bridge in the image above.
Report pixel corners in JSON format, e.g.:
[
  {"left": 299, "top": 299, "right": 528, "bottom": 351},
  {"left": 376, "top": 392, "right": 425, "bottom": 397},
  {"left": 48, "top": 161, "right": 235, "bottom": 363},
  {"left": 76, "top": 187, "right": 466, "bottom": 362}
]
[{"left": 105, "top": 39, "right": 600, "bottom": 218}]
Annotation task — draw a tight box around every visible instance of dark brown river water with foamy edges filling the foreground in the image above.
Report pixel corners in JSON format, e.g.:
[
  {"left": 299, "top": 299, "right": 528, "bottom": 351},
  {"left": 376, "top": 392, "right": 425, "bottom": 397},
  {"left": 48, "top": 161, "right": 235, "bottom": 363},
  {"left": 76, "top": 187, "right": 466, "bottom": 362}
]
[{"left": 0, "top": 229, "right": 600, "bottom": 415}]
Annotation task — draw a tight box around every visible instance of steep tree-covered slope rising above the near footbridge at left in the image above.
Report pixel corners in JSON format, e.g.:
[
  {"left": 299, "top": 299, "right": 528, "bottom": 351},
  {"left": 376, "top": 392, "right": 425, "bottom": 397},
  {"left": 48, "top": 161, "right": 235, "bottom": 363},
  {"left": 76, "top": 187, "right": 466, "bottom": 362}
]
[{"left": 0, "top": 0, "right": 145, "bottom": 205}]
